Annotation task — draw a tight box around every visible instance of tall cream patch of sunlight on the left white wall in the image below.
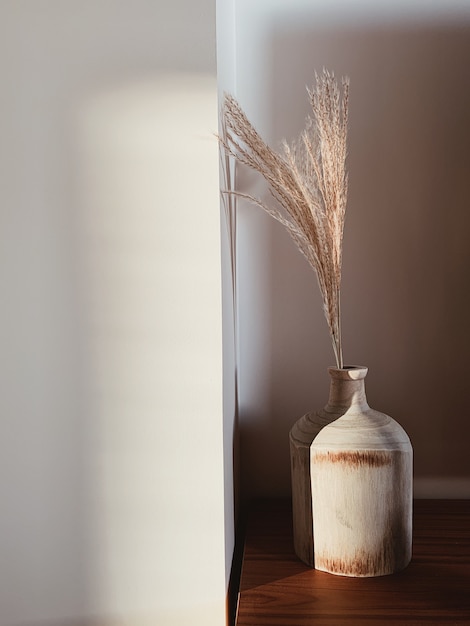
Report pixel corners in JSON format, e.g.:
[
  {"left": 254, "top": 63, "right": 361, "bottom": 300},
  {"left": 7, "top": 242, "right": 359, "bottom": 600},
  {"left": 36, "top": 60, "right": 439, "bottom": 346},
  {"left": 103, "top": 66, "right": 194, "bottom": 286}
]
[{"left": 75, "top": 74, "right": 225, "bottom": 626}]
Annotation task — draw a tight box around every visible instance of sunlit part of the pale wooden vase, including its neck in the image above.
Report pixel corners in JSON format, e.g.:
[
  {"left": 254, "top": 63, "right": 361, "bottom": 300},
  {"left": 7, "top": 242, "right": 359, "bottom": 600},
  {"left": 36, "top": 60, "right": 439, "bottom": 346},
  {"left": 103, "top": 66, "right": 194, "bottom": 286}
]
[{"left": 310, "top": 367, "right": 413, "bottom": 577}]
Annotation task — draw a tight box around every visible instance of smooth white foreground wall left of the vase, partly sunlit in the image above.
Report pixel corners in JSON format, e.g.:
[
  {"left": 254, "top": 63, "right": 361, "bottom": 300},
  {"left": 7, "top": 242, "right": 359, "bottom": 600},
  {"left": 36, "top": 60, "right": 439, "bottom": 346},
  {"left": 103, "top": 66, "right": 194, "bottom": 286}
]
[{"left": 0, "top": 0, "right": 233, "bottom": 626}]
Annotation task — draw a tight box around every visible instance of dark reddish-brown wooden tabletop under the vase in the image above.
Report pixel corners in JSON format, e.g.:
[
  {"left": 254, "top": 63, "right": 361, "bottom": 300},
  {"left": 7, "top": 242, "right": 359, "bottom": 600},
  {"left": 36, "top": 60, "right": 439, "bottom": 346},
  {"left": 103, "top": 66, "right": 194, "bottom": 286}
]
[{"left": 236, "top": 500, "right": 470, "bottom": 626}]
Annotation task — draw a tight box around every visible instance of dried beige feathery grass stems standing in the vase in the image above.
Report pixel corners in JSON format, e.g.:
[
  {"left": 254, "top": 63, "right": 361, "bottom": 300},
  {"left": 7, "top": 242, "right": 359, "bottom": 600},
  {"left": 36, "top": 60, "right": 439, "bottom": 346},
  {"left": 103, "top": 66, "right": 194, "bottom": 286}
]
[{"left": 219, "top": 70, "right": 349, "bottom": 368}]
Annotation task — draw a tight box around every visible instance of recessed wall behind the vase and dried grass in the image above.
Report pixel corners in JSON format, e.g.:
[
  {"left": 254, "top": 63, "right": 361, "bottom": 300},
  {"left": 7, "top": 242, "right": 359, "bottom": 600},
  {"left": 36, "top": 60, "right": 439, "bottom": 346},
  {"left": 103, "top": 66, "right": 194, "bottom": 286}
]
[{"left": 230, "top": 0, "right": 470, "bottom": 497}]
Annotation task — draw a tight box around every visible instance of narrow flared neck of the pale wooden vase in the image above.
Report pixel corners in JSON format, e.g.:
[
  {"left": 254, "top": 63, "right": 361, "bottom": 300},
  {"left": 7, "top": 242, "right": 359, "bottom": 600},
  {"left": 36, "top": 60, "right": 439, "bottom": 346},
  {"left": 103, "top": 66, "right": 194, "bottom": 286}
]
[{"left": 325, "top": 366, "right": 370, "bottom": 412}]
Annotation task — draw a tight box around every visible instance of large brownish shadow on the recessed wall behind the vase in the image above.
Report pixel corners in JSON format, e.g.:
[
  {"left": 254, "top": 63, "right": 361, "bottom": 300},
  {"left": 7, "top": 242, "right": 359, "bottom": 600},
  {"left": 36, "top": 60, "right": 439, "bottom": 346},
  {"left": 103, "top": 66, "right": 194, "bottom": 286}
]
[{"left": 237, "top": 17, "right": 470, "bottom": 495}]
